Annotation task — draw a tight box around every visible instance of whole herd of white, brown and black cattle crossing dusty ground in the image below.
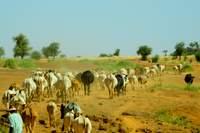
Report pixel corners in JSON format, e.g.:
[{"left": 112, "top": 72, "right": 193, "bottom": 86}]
[{"left": 2, "top": 64, "right": 194, "bottom": 133}]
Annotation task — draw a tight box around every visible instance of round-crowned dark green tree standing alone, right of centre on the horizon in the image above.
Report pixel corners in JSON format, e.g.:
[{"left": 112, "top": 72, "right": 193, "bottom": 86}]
[{"left": 137, "top": 45, "right": 152, "bottom": 60}]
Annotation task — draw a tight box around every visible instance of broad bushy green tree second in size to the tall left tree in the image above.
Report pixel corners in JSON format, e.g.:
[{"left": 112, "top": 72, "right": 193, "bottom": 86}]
[{"left": 42, "top": 42, "right": 60, "bottom": 58}]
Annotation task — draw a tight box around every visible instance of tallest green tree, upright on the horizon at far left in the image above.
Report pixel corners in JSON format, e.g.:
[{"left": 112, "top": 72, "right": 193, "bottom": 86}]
[{"left": 13, "top": 34, "right": 31, "bottom": 59}]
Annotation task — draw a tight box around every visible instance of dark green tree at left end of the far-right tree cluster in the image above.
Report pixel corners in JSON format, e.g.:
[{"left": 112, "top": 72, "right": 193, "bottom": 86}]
[{"left": 174, "top": 42, "right": 185, "bottom": 60}]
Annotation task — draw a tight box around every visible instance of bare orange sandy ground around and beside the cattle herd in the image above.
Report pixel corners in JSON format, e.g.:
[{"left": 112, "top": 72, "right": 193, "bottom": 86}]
[{"left": 0, "top": 60, "right": 200, "bottom": 133}]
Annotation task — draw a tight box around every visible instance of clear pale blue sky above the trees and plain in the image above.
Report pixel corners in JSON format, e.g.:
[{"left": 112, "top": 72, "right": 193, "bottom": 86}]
[{"left": 0, "top": 0, "right": 200, "bottom": 56}]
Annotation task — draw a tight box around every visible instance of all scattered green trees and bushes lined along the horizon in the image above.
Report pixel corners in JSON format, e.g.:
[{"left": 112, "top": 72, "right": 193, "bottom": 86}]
[{"left": 0, "top": 34, "right": 200, "bottom": 62}]
